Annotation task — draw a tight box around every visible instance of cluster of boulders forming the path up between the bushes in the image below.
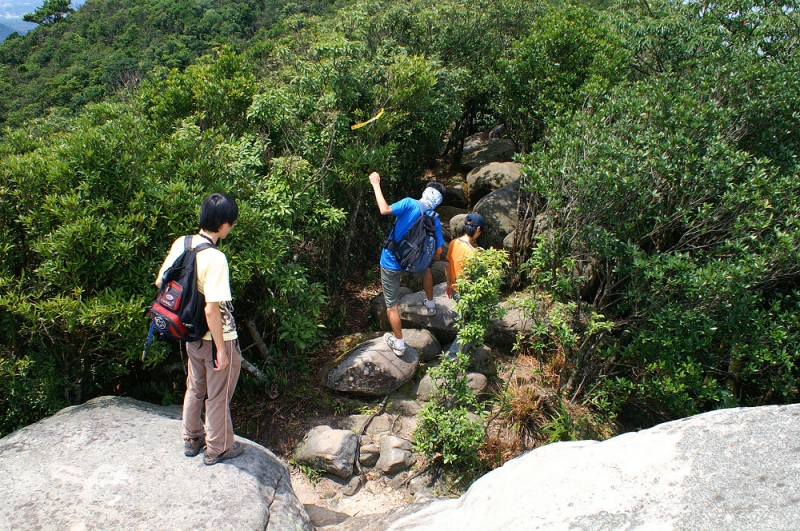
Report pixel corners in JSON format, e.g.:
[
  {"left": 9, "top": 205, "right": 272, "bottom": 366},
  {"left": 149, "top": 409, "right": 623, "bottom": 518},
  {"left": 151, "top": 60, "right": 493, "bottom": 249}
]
[{"left": 293, "top": 133, "right": 523, "bottom": 500}]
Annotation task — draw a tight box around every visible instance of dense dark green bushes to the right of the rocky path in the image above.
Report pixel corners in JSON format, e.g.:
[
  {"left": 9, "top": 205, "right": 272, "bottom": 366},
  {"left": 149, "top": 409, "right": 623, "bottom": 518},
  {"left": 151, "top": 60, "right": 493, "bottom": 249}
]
[{"left": 526, "top": 1, "right": 800, "bottom": 423}]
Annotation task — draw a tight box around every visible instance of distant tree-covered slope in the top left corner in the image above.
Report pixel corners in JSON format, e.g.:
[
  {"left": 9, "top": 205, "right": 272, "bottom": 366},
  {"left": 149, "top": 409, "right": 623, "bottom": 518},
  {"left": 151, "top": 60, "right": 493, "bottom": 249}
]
[{"left": 0, "top": 0, "right": 330, "bottom": 125}]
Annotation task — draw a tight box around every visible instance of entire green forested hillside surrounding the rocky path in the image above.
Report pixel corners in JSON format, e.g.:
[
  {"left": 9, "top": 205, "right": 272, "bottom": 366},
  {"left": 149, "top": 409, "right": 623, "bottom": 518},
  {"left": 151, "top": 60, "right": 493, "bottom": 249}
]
[{"left": 0, "top": 0, "right": 800, "bottom": 482}]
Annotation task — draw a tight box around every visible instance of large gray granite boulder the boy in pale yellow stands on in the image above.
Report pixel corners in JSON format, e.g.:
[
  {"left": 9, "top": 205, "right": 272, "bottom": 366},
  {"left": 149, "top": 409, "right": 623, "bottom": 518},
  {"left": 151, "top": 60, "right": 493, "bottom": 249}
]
[{"left": 0, "top": 397, "right": 313, "bottom": 531}]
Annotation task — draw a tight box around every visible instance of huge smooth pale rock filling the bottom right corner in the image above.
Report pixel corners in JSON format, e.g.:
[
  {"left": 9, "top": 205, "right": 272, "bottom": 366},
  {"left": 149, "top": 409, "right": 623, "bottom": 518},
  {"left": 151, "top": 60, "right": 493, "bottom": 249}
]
[{"left": 388, "top": 405, "right": 800, "bottom": 531}]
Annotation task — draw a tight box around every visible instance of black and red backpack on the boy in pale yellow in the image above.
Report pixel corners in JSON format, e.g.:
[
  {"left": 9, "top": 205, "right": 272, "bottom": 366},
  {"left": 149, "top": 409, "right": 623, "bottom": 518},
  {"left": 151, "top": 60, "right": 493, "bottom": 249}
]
[{"left": 142, "top": 234, "right": 215, "bottom": 359}]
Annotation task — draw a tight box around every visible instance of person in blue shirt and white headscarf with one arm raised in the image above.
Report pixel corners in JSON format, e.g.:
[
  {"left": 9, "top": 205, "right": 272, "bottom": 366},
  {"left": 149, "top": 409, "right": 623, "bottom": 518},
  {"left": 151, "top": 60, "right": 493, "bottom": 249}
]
[{"left": 369, "top": 172, "right": 445, "bottom": 356}]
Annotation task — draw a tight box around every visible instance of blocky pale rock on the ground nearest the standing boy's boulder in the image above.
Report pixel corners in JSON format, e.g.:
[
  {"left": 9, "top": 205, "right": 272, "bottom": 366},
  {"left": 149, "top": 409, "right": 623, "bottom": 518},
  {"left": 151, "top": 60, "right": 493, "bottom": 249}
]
[{"left": 293, "top": 426, "right": 358, "bottom": 478}]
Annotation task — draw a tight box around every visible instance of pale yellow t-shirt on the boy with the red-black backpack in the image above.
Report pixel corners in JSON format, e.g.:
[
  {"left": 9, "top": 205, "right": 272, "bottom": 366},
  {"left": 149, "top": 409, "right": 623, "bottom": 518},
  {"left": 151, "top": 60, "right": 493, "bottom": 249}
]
[{"left": 158, "top": 234, "right": 239, "bottom": 341}]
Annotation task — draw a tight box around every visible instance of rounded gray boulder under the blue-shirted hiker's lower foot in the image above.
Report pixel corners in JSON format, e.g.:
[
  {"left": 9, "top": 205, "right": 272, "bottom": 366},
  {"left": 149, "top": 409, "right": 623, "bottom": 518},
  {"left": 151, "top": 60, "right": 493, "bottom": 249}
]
[{"left": 323, "top": 337, "right": 419, "bottom": 396}]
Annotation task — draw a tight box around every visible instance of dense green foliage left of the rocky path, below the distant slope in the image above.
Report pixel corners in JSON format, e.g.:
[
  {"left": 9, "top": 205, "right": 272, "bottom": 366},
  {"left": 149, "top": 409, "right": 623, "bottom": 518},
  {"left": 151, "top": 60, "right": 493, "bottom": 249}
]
[{"left": 0, "top": 2, "right": 544, "bottom": 431}]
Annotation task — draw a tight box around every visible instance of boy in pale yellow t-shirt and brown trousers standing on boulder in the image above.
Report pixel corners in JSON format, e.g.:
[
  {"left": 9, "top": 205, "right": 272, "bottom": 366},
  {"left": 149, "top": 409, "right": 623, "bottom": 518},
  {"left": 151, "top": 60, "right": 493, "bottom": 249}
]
[{"left": 155, "top": 193, "right": 244, "bottom": 465}]
